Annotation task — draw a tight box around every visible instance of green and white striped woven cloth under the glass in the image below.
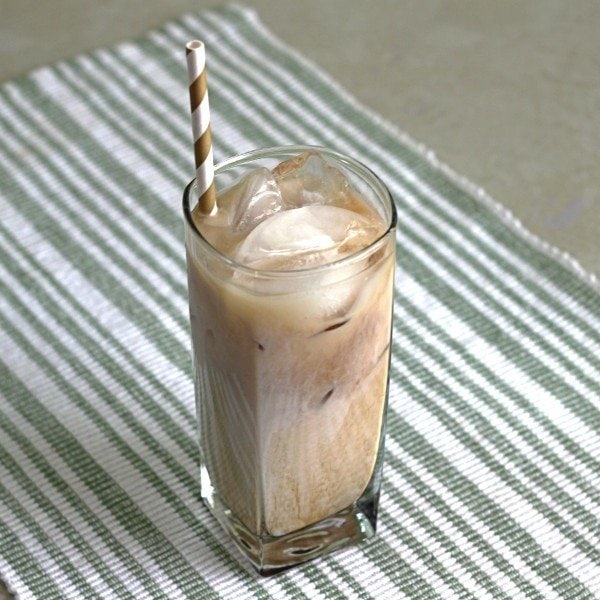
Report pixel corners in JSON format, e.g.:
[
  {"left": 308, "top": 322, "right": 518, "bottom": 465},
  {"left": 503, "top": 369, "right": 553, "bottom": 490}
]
[{"left": 0, "top": 7, "right": 600, "bottom": 600}]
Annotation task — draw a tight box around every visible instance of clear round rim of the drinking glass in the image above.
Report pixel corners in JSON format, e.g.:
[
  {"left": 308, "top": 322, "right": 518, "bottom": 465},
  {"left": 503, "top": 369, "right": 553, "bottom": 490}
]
[{"left": 183, "top": 145, "right": 398, "bottom": 278}]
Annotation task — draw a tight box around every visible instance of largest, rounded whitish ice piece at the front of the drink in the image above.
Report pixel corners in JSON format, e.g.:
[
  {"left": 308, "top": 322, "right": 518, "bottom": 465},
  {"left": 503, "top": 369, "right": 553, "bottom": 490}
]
[{"left": 235, "top": 205, "right": 381, "bottom": 270}]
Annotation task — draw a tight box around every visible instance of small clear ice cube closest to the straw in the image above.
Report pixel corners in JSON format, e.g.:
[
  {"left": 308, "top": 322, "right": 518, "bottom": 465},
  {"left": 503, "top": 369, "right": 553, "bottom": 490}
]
[{"left": 219, "top": 167, "right": 283, "bottom": 234}]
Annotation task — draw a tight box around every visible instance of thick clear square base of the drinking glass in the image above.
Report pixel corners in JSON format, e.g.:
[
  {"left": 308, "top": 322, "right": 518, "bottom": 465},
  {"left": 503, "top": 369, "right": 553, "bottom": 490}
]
[{"left": 200, "top": 465, "right": 379, "bottom": 576}]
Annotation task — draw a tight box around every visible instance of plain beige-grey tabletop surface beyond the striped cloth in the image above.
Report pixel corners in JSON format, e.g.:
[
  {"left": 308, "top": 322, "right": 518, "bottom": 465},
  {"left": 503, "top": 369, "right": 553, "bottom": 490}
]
[{"left": 0, "top": 0, "right": 600, "bottom": 598}]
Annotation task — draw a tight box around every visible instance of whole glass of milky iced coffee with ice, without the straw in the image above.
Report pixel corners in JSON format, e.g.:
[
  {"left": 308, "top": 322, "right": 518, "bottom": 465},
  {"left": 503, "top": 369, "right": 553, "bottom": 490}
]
[{"left": 184, "top": 148, "right": 396, "bottom": 573}]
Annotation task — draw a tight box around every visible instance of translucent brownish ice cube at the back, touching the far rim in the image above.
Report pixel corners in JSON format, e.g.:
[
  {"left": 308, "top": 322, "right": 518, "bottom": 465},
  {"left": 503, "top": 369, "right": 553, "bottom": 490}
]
[{"left": 273, "top": 150, "right": 356, "bottom": 209}]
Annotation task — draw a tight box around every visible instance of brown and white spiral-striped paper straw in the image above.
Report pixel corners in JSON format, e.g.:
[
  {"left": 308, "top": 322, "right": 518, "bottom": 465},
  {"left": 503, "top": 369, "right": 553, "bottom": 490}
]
[{"left": 185, "top": 40, "right": 217, "bottom": 214}]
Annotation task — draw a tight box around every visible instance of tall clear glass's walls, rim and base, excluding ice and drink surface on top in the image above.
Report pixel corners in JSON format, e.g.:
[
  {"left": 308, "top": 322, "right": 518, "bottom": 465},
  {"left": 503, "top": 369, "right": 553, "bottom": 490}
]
[{"left": 183, "top": 146, "right": 396, "bottom": 574}]
